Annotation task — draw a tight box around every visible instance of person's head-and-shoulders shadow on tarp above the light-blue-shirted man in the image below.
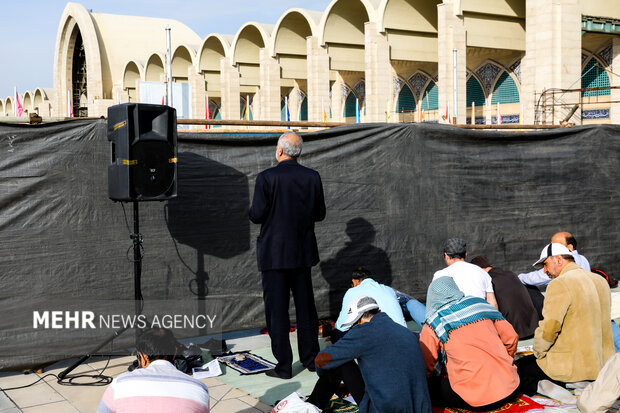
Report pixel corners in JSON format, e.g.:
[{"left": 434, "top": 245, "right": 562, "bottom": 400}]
[{"left": 321, "top": 217, "right": 392, "bottom": 319}]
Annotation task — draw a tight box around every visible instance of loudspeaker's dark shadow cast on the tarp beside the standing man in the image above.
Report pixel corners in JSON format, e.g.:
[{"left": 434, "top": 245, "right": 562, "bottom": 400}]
[{"left": 165, "top": 152, "right": 250, "bottom": 332}]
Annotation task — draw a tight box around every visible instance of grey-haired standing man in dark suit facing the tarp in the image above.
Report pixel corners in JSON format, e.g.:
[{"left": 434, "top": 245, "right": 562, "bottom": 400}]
[{"left": 250, "top": 132, "right": 325, "bottom": 379}]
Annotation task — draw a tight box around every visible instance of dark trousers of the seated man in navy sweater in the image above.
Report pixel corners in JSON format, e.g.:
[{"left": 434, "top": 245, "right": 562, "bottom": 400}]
[{"left": 308, "top": 361, "right": 365, "bottom": 409}]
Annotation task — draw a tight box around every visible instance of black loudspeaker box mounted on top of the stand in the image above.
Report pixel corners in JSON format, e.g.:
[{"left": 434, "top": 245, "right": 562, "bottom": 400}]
[{"left": 108, "top": 103, "right": 177, "bottom": 202}]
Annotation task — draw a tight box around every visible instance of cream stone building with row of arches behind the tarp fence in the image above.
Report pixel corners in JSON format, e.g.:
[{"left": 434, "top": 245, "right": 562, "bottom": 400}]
[{"left": 0, "top": 0, "right": 620, "bottom": 124}]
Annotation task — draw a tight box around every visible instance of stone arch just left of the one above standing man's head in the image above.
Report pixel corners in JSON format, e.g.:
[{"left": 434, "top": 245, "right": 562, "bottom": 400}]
[{"left": 231, "top": 22, "right": 274, "bottom": 86}]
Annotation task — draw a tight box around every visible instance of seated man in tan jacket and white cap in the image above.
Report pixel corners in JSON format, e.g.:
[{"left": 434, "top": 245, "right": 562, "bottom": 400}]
[{"left": 516, "top": 243, "right": 614, "bottom": 395}]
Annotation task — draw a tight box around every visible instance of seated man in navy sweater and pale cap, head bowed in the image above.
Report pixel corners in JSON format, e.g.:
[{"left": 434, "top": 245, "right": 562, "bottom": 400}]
[{"left": 307, "top": 297, "right": 431, "bottom": 413}]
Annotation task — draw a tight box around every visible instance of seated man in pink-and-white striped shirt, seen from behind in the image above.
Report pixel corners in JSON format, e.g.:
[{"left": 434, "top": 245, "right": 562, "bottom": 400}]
[{"left": 97, "top": 328, "right": 209, "bottom": 413}]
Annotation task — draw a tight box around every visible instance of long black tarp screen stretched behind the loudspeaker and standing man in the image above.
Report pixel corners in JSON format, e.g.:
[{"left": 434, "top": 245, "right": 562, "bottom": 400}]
[{"left": 0, "top": 120, "right": 620, "bottom": 369}]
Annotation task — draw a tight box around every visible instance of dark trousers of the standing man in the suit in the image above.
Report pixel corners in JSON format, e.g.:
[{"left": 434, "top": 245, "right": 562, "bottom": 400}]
[{"left": 262, "top": 267, "right": 319, "bottom": 375}]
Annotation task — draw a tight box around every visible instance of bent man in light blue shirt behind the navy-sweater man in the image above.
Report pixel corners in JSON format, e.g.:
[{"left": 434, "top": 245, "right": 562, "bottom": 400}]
[{"left": 335, "top": 267, "right": 407, "bottom": 341}]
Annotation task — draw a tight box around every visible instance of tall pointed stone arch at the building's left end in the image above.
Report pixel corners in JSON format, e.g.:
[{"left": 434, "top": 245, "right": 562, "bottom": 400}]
[{"left": 54, "top": 3, "right": 104, "bottom": 116}]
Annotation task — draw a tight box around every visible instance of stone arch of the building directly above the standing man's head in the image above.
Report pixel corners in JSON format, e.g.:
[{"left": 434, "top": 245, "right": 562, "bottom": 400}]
[{"left": 270, "top": 9, "right": 322, "bottom": 79}]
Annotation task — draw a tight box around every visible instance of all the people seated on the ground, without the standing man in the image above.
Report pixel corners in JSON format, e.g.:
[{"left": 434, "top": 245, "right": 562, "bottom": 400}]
[{"left": 99, "top": 233, "right": 620, "bottom": 413}]
